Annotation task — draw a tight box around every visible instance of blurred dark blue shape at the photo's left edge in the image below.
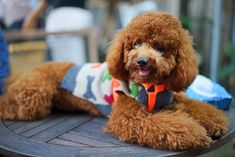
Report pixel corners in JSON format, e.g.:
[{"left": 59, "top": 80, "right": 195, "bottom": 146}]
[{"left": 0, "top": 28, "right": 10, "bottom": 94}]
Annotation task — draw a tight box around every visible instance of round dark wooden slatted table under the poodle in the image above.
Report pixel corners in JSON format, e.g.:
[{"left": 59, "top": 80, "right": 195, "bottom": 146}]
[{"left": 0, "top": 108, "right": 235, "bottom": 157}]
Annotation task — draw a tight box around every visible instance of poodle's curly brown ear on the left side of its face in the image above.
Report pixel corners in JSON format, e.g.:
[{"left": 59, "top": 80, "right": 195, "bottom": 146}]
[{"left": 106, "top": 30, "right": 129, "bottom": 80}]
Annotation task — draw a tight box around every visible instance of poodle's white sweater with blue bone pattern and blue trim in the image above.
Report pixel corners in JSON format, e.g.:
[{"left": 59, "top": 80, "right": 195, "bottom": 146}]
[{"left": 61, "top": 63, "right": 172, "bottom": 116}]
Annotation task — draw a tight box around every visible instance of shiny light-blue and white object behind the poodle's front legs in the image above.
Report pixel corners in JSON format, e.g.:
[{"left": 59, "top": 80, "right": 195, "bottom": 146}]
[{"left": 186, "top": 75, "right": 232, "bottom": 110}]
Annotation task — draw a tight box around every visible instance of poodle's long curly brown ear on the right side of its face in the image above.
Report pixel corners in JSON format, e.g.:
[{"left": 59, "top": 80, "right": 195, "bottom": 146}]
[{"left": 166, "top": 31, "right": 198, "bottom": 92}]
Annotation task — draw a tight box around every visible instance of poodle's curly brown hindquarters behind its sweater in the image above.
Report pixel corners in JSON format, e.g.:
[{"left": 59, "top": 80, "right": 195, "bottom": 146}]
[{"left": 0, "top": 63, "right": 72, "bottom": 120}]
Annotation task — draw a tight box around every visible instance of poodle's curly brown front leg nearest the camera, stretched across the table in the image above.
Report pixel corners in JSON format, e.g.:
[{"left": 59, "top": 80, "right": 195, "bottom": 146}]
[{"left": 104, "top": 94, "right": 211, "bottom": 150}]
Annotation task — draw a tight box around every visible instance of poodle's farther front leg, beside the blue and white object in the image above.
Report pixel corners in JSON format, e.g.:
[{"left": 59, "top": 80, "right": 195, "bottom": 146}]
[{"left": 174, "top": 93, "right": 228, "bottom": 137}]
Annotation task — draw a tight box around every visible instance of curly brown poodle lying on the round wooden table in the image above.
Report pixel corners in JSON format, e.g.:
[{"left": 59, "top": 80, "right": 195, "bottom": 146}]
[{"left": 0, "top": 12, "right": 227, "bottom": 150}]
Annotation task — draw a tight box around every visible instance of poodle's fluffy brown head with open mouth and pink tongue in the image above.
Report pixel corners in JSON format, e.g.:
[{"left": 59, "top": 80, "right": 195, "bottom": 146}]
[{"left": 106, "top": 12, "right": 198, "bottom": 91}]
